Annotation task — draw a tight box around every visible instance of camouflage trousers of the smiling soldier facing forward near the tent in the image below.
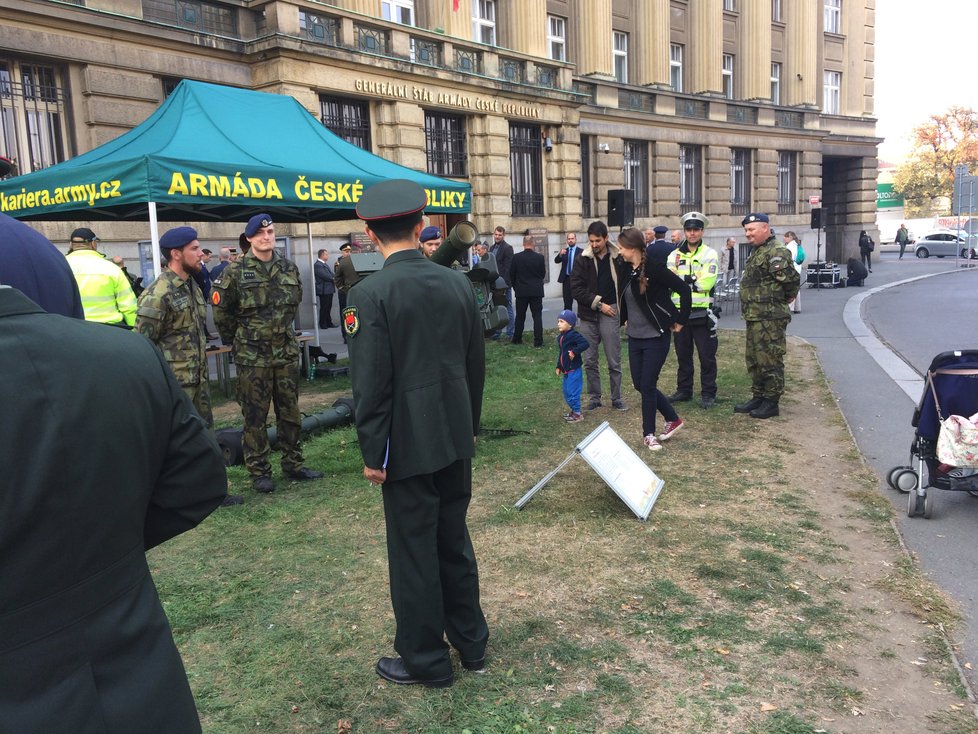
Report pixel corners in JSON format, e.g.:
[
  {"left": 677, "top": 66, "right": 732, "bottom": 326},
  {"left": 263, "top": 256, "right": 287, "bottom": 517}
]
[{"left": 237, "top": 363, "right": 303, "bottom": 477}]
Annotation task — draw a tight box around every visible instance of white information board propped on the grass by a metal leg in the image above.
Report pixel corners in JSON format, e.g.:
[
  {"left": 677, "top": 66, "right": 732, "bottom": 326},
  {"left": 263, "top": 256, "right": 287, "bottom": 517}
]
[{"left": 516, "top": 421, "right": 665, "bottom": 520}]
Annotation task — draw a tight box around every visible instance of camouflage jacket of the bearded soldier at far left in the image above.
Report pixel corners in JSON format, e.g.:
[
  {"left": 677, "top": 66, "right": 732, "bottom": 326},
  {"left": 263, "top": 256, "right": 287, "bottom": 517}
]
[{"left": 135, "top": 270, "right": 207, "bottom": 385}]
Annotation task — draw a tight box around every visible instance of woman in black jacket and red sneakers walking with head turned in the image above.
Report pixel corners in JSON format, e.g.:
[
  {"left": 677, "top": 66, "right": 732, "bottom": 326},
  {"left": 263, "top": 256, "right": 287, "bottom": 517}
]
[{"left": 617, "top": 228, "right": 692, "bottom": 451}]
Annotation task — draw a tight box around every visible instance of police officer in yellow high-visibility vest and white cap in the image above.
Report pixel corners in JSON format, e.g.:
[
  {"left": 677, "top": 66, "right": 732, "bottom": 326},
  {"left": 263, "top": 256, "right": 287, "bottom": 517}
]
[{"left": 667, "top": 212, "right": 719, "bottom": 408}]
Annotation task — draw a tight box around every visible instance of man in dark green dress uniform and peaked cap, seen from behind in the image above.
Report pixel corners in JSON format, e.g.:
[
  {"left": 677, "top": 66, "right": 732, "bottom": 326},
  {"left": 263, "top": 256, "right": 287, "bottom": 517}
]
[{"left": 342, "top": 180, "right": 489, "bottom": 687}]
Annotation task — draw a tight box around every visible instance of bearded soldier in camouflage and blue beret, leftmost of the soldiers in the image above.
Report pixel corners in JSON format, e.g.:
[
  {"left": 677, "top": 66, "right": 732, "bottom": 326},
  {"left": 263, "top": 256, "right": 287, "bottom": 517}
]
[{"left": 133, "top": 227, "right": 244, "bottom": 507}]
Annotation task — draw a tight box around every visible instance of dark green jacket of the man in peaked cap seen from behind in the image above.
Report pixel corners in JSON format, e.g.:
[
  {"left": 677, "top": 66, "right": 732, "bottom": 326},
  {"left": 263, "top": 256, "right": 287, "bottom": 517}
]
[{"left": 344, "top": 250, "right": 485, "bottom": 481}]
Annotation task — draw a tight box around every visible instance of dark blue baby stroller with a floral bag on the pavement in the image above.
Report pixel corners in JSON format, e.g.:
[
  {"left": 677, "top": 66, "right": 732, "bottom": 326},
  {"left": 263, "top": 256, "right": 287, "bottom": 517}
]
[{"left": 886, "top": 349, "right": 978, "bottom": 518}]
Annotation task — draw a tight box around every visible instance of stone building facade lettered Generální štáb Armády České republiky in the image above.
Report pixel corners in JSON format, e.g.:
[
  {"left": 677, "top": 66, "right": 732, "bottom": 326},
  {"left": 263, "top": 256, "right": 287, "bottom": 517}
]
[{"left": 0, "top": 0, "right": 879, "bottom": 302}]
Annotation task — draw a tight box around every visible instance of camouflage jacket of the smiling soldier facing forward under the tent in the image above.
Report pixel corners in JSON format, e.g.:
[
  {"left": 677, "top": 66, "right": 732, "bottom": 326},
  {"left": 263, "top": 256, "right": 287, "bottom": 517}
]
[{"left": 211, "top": 252, "right": 302, "bottom": 367}]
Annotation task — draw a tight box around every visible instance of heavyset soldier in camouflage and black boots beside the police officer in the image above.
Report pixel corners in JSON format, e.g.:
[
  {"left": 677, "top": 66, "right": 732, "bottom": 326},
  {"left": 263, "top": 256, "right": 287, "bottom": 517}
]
[{"left": 734, "top": 213, "right": 800, "bottom": 418}]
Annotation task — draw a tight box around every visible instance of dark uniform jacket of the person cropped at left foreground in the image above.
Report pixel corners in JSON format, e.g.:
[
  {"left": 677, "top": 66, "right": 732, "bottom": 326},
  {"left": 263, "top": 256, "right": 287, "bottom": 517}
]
[{"left": 0, "top": 287, "right": 227, "bottom": 734}]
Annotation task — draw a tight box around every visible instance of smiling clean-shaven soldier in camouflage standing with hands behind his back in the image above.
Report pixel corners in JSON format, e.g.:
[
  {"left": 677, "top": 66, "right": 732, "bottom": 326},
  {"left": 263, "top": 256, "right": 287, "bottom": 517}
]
[{"left": 211, "top": 214, "right": 323, "bottom": 492}]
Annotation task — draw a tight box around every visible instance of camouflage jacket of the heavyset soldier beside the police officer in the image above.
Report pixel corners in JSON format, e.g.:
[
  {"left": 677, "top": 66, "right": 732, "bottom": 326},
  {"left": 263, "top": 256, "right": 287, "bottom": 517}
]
[{"left": 740, "top": 237, "right": 800, "bottom": 321}]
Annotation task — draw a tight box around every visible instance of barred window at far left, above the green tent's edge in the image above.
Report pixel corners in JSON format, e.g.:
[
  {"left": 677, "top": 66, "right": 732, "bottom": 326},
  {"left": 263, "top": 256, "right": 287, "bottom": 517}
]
[{"left": 0, "top": 59, "right": 68, "bottom": 174}]
